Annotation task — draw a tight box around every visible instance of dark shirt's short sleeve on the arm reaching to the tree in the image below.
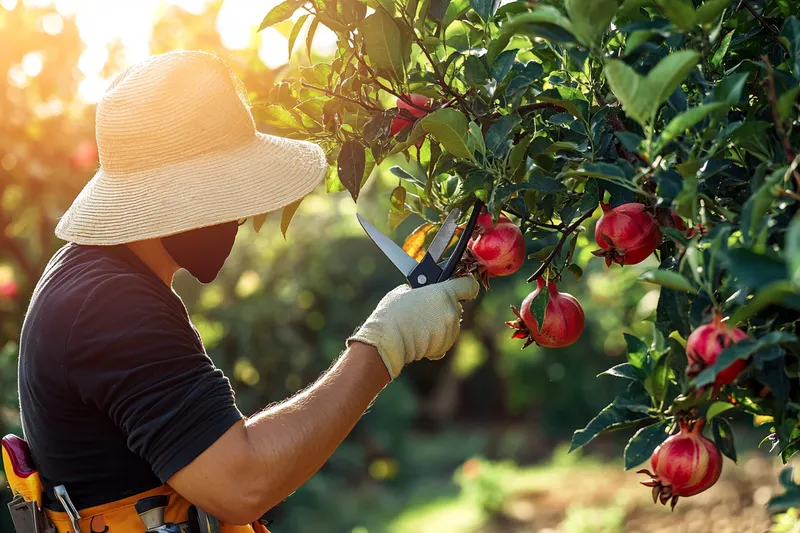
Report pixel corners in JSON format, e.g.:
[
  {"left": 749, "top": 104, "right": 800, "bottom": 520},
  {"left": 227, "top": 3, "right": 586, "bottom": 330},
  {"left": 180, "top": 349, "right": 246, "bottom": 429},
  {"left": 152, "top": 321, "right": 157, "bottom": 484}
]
[{"left": 65, "top": 274, "right": 243, "bottom": 483}]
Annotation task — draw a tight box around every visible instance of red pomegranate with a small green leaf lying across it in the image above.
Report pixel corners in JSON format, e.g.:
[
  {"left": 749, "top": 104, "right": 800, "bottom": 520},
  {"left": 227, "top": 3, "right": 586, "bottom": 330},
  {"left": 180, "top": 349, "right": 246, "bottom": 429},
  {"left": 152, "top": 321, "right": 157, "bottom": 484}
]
[{"left": 506, "top": 278, "right": 584, "bottom": 349}]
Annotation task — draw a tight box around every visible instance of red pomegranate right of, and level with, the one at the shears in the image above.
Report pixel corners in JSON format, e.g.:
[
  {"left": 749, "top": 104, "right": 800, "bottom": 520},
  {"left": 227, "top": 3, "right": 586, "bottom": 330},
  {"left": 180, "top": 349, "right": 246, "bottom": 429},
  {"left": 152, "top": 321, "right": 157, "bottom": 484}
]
[{"left": 592, "top": 202, "right": 661, "bottom": 266}]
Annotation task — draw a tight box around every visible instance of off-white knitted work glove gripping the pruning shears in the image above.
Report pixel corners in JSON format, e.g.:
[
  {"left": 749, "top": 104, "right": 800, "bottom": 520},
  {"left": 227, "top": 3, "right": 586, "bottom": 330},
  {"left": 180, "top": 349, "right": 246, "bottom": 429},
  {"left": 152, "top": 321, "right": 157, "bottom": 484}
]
[{"left": 347, "top": 276, "right": 480, "bottom": 379}]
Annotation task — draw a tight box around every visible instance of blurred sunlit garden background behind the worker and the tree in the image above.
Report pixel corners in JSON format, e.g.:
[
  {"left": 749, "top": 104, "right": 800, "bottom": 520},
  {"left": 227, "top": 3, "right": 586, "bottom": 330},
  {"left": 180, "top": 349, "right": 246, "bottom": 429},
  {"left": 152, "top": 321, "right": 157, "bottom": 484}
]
[{"left": 0, "top": 0, "right": 800, "bottom": 533}]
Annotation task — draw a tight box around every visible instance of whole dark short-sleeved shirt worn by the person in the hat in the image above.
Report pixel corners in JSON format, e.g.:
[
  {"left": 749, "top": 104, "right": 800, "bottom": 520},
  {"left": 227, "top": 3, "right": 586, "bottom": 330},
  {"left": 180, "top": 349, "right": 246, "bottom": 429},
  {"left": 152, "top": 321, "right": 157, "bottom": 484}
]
[{"left": 19, "top": 244, "right": 242, "bottom": 509}]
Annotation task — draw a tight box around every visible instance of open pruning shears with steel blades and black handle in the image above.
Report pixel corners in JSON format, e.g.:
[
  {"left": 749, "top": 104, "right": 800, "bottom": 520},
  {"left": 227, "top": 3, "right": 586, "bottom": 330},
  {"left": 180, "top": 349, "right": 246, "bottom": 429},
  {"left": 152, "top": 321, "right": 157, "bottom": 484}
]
[{"left": 357, "top": 200, "right": 483, "bottom": 289}]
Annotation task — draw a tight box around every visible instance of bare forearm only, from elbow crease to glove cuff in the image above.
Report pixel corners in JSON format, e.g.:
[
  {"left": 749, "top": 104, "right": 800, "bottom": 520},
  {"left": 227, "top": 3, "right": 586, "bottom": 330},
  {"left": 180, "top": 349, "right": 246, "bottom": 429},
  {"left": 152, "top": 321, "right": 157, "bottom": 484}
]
[{"left": 245, "top": 343, "right": 389, "bottom": 511}]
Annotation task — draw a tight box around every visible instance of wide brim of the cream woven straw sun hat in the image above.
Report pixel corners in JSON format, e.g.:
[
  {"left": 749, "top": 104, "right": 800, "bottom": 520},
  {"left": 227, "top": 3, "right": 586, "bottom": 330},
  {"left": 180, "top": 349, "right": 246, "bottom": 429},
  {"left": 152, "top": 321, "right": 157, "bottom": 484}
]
[{"left": 56, "top": 133, "right": 327, "bottom": 246}]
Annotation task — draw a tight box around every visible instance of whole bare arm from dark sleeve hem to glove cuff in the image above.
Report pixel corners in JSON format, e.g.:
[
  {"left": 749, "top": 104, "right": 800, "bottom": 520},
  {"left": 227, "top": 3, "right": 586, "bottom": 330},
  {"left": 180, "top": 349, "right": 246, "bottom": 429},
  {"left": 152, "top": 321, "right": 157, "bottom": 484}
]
[{"left": 168, "top": 342, "right": 389, "bottom": 524}]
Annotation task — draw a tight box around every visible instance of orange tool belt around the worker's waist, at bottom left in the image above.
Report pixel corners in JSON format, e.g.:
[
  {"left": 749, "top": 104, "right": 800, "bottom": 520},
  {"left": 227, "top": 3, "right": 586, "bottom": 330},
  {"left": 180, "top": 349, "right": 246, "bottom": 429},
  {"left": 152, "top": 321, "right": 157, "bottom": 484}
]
[{"left": 2, "top": 435, "right": 269, "bottom": 533}]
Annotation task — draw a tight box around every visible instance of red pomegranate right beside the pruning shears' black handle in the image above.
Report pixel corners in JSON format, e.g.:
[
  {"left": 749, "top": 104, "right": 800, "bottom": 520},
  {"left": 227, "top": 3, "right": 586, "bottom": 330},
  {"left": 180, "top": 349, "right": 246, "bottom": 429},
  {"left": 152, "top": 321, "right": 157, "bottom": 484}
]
[{"left": 462, "top": 213, "right": 525, "bottom": 286}]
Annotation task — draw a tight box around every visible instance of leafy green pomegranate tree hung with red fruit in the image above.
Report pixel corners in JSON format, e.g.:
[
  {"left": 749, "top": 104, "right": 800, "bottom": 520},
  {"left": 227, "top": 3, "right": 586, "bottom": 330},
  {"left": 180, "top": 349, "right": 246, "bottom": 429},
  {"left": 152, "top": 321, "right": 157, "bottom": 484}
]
[{"left": 255, "top": 0, "right": 800, "bottom": 507}]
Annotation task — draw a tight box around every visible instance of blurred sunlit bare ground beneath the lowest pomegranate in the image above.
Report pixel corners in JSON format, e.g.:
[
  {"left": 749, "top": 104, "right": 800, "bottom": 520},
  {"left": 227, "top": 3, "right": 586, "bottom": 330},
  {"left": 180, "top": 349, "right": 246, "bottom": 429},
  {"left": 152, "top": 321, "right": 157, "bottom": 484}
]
[{"left": 496, "top": 456, "right": 781, "bottom": 533}]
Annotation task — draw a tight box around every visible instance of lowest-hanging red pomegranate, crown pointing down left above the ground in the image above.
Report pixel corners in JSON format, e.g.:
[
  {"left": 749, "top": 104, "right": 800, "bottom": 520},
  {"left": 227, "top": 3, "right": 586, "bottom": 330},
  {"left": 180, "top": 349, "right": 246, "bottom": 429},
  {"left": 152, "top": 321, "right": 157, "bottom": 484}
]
[{"left": 637, "top": 418, "right": 722, "bottom": 509}]
